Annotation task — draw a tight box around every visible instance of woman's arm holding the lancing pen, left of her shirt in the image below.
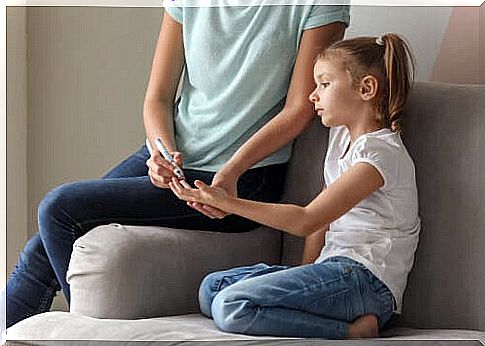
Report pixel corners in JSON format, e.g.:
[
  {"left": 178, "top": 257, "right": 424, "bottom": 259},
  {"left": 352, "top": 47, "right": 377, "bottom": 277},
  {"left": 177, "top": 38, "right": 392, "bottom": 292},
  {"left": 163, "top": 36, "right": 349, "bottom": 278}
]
[{"left": 143, "top": 12, "right": 185, "bottom": 188}]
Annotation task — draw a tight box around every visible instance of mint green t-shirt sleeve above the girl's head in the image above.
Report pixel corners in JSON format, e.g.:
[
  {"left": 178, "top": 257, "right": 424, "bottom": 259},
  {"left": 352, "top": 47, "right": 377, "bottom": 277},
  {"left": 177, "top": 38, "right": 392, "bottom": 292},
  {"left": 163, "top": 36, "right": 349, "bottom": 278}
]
[{"left": 303, "top": 5, "right": 350, "bottom": 30}]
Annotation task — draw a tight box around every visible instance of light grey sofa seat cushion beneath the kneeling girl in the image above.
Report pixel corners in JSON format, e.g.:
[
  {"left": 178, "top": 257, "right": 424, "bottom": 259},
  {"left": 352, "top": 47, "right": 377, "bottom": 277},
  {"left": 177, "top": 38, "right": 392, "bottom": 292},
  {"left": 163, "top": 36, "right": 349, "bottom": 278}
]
[{"left": 7, "top": 311, "right": 485, "bottom": 345}]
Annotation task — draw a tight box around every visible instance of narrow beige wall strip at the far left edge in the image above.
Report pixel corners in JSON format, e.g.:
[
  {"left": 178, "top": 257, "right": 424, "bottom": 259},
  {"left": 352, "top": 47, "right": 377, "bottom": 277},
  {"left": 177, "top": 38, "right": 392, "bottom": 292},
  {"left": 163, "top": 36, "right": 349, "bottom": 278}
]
[{"left": 6, "top": 7, "right": 28, "bottom": 287}]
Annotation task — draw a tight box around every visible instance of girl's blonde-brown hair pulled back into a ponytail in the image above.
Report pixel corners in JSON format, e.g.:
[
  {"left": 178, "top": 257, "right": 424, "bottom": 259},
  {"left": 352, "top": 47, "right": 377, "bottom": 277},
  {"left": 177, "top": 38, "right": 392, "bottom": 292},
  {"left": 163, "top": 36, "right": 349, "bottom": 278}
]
[{"left": 316, "top": 33, "right": 414, "bottom": 131}]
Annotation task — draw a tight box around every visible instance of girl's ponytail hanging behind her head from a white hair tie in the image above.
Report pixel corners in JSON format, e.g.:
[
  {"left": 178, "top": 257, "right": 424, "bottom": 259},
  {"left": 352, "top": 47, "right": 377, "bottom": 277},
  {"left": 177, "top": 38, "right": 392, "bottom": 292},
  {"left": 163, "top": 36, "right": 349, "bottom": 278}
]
[{"left": 376, "top": 33, "right": 414, "bottom": 131}]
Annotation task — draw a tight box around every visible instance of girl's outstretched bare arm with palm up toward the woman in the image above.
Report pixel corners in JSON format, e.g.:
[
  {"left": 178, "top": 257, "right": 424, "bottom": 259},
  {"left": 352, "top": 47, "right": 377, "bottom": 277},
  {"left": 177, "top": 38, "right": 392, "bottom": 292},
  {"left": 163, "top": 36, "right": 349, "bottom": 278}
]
[{"left": 170, "top": 162, "right": 384, "bottom": 237}]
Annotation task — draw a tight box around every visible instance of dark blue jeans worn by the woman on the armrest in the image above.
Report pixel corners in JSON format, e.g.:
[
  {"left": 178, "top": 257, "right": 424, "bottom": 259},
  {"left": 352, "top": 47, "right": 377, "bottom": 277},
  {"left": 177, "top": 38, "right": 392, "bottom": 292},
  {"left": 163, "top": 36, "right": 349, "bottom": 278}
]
[{"left": 0, "top": 146, "right": 286, "bottom": 328}]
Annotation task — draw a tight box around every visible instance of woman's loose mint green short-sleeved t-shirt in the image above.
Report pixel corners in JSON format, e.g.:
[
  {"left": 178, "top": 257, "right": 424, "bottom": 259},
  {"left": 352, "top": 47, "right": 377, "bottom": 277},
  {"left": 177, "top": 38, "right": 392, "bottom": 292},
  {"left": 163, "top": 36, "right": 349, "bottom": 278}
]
[{"left": 165, "top": 1, "right": 350, "bottom": 172}]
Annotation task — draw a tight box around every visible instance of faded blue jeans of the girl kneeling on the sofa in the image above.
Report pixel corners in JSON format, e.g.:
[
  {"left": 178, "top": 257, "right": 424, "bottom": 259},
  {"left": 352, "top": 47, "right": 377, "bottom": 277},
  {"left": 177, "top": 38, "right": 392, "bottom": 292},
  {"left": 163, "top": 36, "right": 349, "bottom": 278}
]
[{"left": 199, "top": 257, "right": 394, "bottom": 339}]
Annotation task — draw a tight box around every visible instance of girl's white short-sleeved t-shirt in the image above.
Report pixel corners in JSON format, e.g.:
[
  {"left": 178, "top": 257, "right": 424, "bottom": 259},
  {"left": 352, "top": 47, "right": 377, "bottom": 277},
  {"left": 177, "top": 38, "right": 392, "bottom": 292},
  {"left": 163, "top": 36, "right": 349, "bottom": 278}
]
[{"left": 315, "top": 126, "right": 421, "bottom": 313}]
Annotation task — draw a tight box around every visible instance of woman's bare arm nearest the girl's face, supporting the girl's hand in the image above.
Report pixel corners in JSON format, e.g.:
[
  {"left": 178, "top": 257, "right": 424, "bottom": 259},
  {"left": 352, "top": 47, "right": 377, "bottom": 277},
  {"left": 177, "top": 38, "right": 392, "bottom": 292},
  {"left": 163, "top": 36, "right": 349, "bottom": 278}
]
[{"left": 190, "top": 22, "right": 345, "bottom": 217}]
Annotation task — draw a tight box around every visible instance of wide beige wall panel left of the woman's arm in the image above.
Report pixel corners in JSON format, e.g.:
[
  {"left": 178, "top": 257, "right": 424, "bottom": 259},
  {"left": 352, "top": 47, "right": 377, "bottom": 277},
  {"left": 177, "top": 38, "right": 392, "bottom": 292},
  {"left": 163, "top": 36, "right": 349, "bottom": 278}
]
[{"left": 27, "top": 7, "right": 161, "bottom": 241}]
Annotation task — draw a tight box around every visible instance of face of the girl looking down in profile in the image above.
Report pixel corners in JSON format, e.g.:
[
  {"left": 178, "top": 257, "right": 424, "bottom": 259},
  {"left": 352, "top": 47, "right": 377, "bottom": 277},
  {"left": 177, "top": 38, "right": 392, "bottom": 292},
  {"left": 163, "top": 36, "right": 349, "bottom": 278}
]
[{"left": 309, "top": 59, "right": 362, "bottom": 127}]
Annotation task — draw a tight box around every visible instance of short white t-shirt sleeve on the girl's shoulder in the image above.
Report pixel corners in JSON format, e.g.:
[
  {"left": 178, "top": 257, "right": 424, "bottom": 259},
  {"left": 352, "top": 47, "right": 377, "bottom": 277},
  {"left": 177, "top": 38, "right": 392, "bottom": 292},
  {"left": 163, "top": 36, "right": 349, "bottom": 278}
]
[{"left": 351, "top": 138, "right": 398, "bottom": 189}]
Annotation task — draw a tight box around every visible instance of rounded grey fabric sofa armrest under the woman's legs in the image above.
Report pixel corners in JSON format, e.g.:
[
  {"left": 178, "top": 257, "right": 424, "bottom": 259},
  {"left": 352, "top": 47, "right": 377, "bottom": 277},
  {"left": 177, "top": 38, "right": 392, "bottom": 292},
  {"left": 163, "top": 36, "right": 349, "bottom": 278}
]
[{"left": 67, "top": 224, "right": 281, "bottom": 319}]
